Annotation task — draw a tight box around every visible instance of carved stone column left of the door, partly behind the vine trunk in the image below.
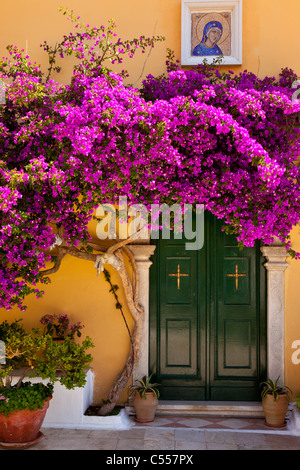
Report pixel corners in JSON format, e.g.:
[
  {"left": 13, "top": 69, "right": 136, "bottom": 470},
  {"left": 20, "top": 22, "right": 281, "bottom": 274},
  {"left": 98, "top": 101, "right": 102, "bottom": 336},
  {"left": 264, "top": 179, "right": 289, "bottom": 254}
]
[{"left": 128, "top": 245, "right": 156, "bottom": 381}]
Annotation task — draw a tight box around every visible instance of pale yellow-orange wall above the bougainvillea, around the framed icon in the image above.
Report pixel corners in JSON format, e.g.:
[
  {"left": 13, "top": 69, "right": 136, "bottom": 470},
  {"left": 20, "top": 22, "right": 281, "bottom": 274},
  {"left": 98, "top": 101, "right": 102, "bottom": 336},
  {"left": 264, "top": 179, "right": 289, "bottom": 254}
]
[{"left": 0, "top": 0, "right": 300, "bottom": 83}]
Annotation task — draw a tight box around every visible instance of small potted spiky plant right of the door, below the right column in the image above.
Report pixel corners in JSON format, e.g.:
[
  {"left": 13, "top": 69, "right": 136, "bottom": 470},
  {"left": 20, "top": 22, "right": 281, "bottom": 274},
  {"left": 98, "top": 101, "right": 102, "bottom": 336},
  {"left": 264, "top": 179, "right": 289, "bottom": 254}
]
[{"left": 260, "top": 377, "right": 292, "bottom": 428}]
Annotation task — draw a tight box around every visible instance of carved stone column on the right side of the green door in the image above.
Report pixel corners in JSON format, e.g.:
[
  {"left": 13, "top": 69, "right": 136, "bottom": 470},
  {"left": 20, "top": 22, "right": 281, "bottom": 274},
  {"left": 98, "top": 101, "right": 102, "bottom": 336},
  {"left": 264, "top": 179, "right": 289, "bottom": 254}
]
[{"left": 261, "top": 246, "right": 288, "bottom": 383}]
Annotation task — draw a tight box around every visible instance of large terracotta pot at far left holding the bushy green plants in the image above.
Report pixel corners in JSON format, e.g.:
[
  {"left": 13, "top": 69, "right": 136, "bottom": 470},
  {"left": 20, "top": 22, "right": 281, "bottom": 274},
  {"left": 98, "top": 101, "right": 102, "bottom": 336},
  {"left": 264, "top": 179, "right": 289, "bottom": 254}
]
[{"left": 0, "top": 398, "right": 51, "bottom": 444}]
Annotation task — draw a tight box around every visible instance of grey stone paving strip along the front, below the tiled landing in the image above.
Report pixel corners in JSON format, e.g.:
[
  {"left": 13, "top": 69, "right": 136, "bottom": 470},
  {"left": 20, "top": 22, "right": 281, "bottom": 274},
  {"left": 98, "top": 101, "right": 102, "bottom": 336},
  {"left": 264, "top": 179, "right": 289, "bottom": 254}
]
[{"left": 35, "top": 427, "right": 300, "bottom": 451}]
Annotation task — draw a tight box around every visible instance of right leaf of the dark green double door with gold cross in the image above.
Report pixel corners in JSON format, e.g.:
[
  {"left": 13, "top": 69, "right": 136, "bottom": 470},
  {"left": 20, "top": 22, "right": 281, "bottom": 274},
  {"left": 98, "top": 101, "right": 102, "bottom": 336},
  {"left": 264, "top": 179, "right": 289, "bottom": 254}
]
[{"left": 210, "top": 222, "right": 266, "bottom": 400}]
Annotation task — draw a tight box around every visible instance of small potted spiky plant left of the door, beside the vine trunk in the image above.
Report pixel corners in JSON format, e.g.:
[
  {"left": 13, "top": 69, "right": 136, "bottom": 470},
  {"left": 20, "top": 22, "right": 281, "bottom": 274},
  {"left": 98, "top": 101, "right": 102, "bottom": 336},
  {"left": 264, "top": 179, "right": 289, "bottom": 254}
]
[{"left": 129, "top": 374, "right": 159, "bottom": 423}]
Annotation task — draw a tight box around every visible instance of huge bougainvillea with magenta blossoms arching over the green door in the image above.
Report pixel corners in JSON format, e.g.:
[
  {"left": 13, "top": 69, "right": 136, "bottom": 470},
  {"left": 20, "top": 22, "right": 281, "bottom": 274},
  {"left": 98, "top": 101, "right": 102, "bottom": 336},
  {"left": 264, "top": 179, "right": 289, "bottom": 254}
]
[{"left": 0, "top": 6, "right": 300, "bottom": 412}]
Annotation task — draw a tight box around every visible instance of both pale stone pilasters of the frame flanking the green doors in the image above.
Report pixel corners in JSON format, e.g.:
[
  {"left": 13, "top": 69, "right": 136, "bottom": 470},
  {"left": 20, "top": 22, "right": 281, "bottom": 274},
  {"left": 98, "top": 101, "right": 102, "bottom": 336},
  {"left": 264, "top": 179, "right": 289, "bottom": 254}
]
[{"left": 129, "top": 244, "right": 288, "bottom": 383}]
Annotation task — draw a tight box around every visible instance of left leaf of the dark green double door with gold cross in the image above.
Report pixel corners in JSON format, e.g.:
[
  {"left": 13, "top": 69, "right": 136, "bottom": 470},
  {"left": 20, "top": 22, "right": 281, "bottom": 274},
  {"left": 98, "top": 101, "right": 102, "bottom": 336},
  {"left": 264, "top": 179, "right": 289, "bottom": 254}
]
[{"left": 154, "top": 239, "right": 205, "bottom": 399}]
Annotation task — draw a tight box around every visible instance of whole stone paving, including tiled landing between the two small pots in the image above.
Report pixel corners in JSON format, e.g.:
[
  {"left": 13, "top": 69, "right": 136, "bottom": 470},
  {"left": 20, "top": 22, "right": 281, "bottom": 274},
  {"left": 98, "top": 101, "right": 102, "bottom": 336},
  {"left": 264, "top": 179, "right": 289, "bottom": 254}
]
[{"left": 2, "top": 416, "right": 300, "bottom": 455}]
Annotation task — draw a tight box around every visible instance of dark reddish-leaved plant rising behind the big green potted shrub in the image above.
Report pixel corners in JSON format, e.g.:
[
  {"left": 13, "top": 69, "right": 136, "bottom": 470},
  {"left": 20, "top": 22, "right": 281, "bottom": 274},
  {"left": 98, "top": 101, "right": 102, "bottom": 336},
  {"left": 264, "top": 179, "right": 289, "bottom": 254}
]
[{"left": 40, "top": 315, "right": 84, "bottom": 341}]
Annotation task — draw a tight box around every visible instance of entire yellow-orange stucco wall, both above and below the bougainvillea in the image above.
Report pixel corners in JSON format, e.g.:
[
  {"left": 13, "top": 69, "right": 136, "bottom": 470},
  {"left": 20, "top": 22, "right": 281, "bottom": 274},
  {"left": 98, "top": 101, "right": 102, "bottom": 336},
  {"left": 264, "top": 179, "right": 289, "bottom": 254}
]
[{"left": 0, "top": 0, "right": 300, "bottom": 401}]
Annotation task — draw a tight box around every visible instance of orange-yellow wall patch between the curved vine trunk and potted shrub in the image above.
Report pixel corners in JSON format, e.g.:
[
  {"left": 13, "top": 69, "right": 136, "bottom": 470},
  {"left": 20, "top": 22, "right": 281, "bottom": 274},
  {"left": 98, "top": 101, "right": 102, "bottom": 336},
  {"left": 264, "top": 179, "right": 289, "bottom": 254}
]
[{"left": 0, "top": 231, "right": 132, "bottom": 403}]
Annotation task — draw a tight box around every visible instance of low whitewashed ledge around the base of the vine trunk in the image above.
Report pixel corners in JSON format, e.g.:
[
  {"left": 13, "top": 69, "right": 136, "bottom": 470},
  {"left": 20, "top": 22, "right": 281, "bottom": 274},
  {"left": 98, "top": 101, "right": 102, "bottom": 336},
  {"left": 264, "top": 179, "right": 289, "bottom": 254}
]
[{"left": 13, "top": 369, "right": 133, "bottom": 430}]
